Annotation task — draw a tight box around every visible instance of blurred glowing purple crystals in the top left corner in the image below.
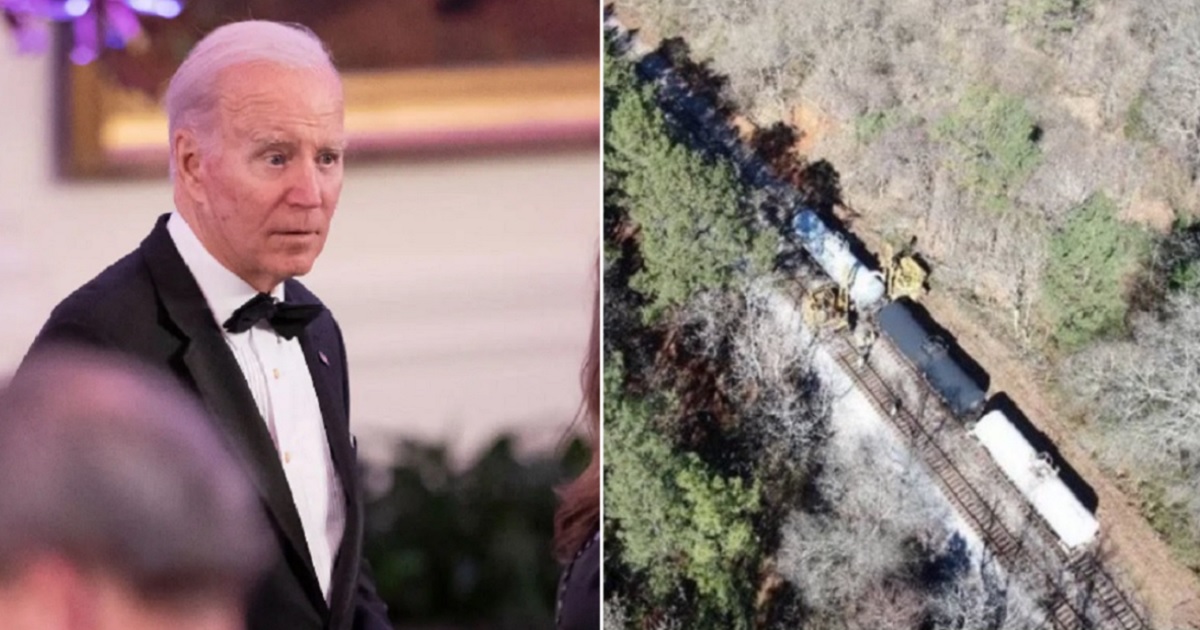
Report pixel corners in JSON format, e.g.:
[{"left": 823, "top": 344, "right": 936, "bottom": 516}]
[{"left": 0, "top": 0, "right": 184, "bottom": 65}]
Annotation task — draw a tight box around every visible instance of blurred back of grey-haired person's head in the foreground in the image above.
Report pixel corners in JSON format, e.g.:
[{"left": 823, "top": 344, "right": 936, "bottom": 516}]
[{"left": 0, "top": 349, "right": 271, "bottom": 630}]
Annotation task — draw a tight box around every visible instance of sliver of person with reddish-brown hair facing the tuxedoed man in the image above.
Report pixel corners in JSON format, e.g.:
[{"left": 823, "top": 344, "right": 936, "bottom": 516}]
[{"left": 554, "top": 273, "right": 600, "bottom": 630}]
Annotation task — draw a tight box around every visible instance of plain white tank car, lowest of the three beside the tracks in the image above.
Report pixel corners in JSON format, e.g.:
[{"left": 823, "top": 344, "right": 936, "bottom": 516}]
[{"left": 971, "top": 410, "right": 1100, "bottom": 548}]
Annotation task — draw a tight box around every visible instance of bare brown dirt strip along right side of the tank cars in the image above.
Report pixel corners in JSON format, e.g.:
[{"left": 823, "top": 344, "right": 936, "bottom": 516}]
[{"left": 854, "top": 216, "right": 1200, "bottom": 630}]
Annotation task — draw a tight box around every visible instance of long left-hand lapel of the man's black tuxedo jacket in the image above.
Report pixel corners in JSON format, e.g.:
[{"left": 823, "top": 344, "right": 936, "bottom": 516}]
[{"left": 142, "top": 215, "right": 325, "bottom": 604}]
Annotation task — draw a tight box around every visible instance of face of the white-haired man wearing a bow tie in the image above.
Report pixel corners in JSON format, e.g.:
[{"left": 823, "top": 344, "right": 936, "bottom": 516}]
[{"left": 183, "top": 62, "right": 346, "bottom": 293}]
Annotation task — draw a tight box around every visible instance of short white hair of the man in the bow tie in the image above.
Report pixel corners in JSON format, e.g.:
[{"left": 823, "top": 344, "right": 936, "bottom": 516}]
[{"left": 163, "top": 20, "right": 337, "bottom": 176}]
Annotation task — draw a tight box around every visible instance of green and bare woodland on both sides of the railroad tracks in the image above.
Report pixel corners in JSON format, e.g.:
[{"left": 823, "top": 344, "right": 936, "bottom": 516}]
[{"left": 605, "top": 0, "right": 1200, "bottom": 628}]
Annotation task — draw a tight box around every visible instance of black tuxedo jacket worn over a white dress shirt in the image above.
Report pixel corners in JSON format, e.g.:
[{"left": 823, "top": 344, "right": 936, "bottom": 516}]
[{"left": 21, "top": 215, "right": 391, "bottom": 630}]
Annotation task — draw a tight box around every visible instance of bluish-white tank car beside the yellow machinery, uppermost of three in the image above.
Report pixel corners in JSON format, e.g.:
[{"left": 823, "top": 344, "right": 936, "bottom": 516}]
[{"left": 792, "top": 209, "right": 884, "bottom": 311}]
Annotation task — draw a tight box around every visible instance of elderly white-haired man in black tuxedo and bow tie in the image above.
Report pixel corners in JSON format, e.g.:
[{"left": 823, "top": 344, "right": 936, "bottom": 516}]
[{"left": 19, "top": 20, "right": 390, "bottom": 630}]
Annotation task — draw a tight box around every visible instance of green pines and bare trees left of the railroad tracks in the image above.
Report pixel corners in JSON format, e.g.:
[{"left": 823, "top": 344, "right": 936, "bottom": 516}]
[{"left": 604, "top": 30, "right": 1032, "bottom": 629}]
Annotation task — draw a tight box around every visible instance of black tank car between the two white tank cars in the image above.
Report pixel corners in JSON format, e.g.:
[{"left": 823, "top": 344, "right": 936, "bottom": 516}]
[{"left": 878, "top": 300, "right": 988, "bottom": 420}]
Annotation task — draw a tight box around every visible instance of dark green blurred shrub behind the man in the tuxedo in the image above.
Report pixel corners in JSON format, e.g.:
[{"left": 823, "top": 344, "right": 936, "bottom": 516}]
[{"left": 364, "top": 437, "right": 588, "bottom": 630}]
